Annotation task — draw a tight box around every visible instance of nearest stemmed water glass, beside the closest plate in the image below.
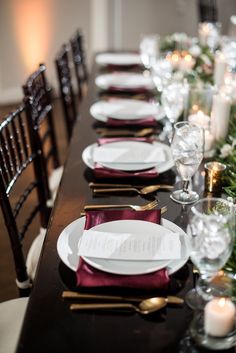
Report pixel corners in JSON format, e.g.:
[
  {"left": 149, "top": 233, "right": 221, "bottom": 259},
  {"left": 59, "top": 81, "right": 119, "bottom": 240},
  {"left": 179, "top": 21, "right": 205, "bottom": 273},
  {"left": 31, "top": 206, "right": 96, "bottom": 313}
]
[{"left": 186, "top": 198, "right": 235, "bottom": 308}]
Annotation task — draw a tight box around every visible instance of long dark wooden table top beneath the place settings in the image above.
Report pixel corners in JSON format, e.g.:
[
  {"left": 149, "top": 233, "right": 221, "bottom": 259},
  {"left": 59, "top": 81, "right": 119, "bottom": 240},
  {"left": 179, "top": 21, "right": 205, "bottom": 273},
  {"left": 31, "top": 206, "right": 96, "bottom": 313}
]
[{"left": 17, "top": 60, "right": 233, "bottom": 353}]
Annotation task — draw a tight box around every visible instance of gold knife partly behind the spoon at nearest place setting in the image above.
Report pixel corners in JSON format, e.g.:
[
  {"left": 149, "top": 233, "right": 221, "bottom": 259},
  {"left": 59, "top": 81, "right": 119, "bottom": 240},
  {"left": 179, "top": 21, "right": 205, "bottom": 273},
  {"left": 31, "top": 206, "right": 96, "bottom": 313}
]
[{"left": 62, "top": 291, "right": 184, "bottom": 304}]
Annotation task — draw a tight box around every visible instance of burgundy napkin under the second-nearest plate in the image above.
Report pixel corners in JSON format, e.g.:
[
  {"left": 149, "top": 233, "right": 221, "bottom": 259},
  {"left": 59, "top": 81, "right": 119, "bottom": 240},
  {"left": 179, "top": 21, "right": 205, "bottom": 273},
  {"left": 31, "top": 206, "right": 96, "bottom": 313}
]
[{"left": 94, "top": 137, "right": 158, "bottom": 178}]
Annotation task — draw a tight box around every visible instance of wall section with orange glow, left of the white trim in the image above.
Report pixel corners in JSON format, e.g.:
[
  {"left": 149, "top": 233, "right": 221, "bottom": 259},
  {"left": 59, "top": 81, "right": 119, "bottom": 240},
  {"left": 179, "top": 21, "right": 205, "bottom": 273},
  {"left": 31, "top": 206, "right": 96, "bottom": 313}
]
[{"left": 0, "top": 0, "right": 91, "bottom": 103}]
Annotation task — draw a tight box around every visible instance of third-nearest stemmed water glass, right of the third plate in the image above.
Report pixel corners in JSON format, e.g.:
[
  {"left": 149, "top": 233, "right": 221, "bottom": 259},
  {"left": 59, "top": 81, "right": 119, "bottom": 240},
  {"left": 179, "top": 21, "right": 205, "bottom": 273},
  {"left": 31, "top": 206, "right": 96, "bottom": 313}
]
[{"left": 161, "top": 81, "right": 184, "bottom": 142}]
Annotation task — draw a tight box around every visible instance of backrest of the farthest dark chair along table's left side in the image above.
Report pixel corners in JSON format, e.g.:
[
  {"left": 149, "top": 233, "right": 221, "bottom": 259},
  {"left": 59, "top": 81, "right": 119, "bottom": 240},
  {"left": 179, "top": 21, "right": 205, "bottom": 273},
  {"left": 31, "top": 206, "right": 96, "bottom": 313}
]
[{"left": 70, "top": 30, "right": 88, "bottom": 98}]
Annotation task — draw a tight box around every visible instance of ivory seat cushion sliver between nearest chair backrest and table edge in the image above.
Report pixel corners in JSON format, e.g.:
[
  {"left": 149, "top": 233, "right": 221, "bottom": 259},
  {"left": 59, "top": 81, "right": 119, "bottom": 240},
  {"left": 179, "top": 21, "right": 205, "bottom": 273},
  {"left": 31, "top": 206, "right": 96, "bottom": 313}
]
[{"left": 26, "top": 228, "right": 47, "bottom": 281}]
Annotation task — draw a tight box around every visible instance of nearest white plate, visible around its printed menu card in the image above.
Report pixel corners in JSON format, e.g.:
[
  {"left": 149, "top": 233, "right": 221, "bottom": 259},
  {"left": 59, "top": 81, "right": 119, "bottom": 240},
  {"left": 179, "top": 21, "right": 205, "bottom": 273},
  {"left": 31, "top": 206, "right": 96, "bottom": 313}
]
[{"left": 57, "top": 217, "right": 190, "bottom": 275}]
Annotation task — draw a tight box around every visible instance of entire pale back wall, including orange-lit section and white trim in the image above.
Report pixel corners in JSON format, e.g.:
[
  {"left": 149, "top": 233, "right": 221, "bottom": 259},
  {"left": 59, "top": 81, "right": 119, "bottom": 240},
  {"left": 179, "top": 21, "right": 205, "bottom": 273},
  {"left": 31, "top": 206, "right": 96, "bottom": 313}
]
[{"left": 0, "top": 0, "right": 236, "bottom": 103}]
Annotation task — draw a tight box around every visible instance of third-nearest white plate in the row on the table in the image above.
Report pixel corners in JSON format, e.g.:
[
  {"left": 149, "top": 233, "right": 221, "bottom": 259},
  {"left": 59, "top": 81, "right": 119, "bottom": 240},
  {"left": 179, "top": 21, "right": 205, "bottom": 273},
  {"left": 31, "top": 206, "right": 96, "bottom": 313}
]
[{"left": 90, "top": 99, "right": 165, "bottom": 122}]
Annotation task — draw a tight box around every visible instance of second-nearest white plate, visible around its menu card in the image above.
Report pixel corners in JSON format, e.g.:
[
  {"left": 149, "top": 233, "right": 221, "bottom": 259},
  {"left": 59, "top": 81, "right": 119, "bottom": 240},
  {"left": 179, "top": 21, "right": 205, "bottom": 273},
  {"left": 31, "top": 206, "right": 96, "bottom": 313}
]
[{"left": 82, "top": 141, "right": 174, "bottom": 173}]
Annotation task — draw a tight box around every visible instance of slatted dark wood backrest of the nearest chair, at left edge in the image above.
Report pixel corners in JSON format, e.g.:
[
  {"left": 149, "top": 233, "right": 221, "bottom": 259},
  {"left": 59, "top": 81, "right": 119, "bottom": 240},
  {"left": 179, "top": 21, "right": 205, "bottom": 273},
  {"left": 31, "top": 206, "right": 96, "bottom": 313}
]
[{"left": 0, "top": 105, "right": 51, "bottom": 295}]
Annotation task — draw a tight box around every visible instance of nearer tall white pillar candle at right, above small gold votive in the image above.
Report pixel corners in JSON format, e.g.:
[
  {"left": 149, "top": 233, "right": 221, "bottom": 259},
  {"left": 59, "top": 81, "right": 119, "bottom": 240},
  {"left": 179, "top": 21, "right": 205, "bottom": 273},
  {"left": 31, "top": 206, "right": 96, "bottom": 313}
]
[{"left": 211, "top": 93, "right": 231, "bottom": 141}]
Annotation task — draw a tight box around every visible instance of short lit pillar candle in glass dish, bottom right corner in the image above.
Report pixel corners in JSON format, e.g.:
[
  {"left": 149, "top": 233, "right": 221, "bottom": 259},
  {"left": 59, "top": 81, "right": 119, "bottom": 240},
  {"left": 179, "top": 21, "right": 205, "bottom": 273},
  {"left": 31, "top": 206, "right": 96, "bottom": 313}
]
[{"left": 204, "top": 298, "right": 235, "bottom": 337}]
